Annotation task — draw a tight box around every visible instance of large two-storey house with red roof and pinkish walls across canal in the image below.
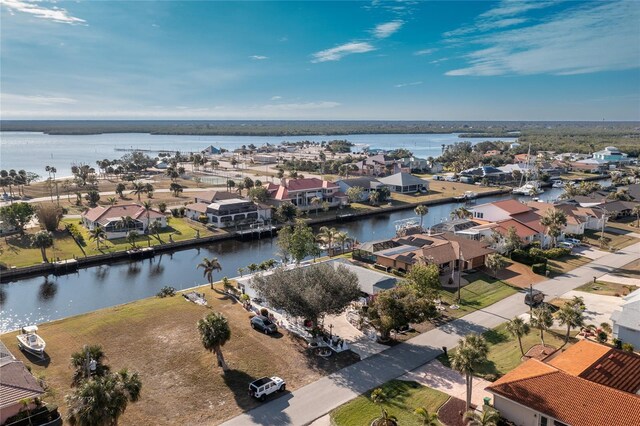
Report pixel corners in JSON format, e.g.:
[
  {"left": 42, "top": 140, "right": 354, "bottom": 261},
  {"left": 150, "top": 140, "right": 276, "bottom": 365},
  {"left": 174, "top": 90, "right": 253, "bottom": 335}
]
[{"left": 266, "top": 178, "right": 348, "bottom": 211}]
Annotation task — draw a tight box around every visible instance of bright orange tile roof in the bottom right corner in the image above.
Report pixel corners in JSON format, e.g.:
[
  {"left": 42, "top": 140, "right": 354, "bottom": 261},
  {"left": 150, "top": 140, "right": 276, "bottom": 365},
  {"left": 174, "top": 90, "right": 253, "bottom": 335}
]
[{"left": 486, "top": 359, "right": 640, "bottom": 426}]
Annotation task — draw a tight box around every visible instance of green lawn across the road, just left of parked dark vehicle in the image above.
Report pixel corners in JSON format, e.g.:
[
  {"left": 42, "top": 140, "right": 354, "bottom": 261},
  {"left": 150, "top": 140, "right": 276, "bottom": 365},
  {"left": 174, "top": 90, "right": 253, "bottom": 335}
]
[{"left": 440, "top": 272, "right": 518, "bottom": 318}]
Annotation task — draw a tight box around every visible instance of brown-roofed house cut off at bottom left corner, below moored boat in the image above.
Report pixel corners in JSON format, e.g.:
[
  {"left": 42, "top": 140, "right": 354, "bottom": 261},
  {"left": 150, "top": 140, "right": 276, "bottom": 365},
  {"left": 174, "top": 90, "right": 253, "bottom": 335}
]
[{"left": 0, "top": 342, "right": 46, "bottom": 425}]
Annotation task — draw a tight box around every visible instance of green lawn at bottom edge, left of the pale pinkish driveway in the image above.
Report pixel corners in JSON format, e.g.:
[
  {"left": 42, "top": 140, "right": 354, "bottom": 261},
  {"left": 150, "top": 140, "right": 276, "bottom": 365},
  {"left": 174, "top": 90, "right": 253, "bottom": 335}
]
[{"left": 331, "top": 380, "right": 449, "bottom": 426}]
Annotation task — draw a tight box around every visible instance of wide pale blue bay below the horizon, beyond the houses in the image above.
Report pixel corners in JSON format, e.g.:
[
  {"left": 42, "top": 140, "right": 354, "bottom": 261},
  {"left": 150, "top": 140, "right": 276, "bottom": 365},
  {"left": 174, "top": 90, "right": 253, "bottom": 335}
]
[{"left": 0, "top": 132, "right": 516, "bottom": 177}]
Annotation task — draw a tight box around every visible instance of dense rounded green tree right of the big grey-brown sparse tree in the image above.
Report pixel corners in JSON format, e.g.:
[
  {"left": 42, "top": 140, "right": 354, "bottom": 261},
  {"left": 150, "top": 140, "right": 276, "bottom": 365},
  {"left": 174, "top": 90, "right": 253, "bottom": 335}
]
[{"left": 367, "top": 284, "right": 437, "bottom": 341}]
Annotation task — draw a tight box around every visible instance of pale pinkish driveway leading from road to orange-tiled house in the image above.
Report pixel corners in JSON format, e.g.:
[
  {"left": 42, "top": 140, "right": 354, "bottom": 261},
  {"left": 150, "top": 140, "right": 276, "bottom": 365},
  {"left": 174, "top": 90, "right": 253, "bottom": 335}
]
[{"left": 399, "top": 359, "right": 491, "bottom": 407}]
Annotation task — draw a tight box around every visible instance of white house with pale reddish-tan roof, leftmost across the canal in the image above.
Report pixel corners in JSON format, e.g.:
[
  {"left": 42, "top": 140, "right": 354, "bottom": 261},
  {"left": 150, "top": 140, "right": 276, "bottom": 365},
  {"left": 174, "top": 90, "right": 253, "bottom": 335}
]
[{"left": 81, "top": 204, "right": 167, "bottom": 240}]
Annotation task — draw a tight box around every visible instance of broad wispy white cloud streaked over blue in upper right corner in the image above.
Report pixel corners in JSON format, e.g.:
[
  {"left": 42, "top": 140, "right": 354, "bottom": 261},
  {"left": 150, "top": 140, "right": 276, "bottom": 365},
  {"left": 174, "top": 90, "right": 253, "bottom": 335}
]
[{"left": 446, "top": 1, "right": 640, "bottom": 76}]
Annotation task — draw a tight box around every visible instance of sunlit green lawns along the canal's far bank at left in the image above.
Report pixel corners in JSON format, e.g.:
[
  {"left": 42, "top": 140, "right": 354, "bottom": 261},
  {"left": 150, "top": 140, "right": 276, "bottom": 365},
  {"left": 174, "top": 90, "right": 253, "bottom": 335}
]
[{"left": 0, "top": 217, "right": 222, "bottom": 267}]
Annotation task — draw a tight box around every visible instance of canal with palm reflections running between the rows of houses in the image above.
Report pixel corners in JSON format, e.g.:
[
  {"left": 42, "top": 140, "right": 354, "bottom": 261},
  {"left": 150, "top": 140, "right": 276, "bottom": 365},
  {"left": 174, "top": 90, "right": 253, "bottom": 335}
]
[{"left": 0, "top": 181, "right": 608, "bottom": 333}]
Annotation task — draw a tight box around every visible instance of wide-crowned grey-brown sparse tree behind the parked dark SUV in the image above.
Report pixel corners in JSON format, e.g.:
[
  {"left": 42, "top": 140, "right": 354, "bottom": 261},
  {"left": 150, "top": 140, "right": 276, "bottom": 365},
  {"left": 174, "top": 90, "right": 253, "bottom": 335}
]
[{"left": 251, "top": 263, "right": 360, "bottom": 325}]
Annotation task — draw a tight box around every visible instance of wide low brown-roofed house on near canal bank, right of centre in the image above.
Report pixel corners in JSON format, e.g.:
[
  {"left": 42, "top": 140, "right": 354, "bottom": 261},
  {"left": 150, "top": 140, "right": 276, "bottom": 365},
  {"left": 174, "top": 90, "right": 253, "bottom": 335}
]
[{"left": 353, "top": 233, "right": 495, "bottom": 273}]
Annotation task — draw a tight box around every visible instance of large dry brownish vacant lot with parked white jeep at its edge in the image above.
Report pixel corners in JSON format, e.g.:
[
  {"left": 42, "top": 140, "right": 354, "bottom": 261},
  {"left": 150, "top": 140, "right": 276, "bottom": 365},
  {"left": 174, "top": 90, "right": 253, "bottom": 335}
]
[{"left": 0, "top": 286, "right": 358, "bottom": 425}]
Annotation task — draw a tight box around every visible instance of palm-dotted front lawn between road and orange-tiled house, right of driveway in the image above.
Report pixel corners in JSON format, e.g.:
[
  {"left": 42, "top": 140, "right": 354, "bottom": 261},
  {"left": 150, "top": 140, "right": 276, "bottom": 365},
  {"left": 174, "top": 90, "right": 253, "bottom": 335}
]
[{"left": 438, "top": 324, "right": 576, "bottom": 381}]
